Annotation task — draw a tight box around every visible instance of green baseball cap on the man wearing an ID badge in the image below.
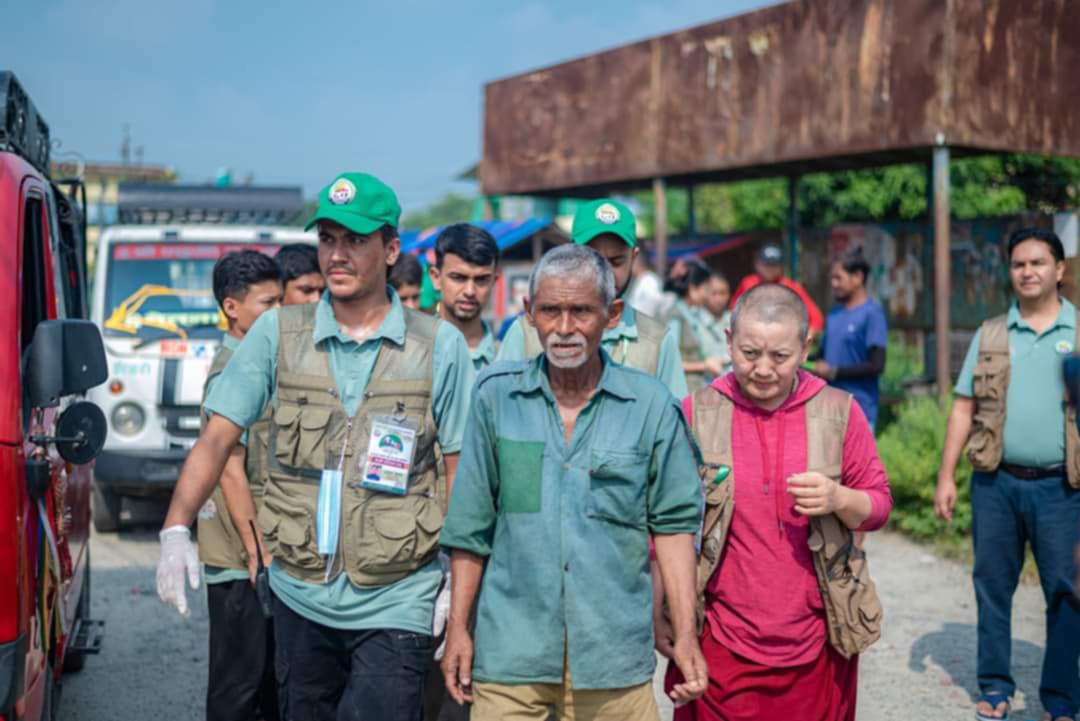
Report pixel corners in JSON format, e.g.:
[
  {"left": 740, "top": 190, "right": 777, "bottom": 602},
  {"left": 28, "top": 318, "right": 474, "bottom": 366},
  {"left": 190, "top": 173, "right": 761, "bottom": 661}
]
[{"left": 303, "top": 173, "right": 402, "bottom": 235}]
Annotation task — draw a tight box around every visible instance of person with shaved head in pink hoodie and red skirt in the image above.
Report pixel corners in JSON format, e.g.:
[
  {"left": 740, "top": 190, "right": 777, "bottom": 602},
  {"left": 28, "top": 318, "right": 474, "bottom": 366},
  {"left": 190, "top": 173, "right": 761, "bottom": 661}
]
[{"left": 656, "top": 284, "right": 892, "bottom": 721}]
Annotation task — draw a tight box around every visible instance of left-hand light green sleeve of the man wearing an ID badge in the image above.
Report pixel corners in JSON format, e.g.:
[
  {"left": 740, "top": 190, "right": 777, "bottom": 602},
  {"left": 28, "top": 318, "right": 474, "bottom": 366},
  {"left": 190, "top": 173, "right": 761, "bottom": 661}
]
[{"left": 203, "top": 309, "right": 279, "bottom": 428}]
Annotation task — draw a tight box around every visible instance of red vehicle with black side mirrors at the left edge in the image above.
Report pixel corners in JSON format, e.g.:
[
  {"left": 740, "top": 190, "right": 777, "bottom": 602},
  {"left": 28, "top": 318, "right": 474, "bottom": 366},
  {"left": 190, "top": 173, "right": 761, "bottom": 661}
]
[{"left": 0, "top": 72, "right": 107, "bottom": 721}]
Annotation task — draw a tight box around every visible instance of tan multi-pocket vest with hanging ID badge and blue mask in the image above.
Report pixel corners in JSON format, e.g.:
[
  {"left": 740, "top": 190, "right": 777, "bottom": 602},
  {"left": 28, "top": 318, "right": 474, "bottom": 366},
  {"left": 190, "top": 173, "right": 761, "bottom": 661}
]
[{"left": 258, "top": 303, "right": 446, "bottom": 586}]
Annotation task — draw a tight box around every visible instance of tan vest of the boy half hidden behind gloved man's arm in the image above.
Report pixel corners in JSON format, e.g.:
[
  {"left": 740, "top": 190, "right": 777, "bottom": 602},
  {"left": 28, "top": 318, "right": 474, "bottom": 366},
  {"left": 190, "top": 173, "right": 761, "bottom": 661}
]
[{"left": 199, "top": 345, "right": 270, "bottom": 571}]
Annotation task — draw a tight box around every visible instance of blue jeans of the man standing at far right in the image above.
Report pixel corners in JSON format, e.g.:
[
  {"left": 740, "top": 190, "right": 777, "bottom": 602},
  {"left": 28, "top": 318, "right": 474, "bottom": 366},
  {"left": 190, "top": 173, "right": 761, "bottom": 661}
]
[{"left": 971, "top": 470, "right": 1080, "bottom": 716}]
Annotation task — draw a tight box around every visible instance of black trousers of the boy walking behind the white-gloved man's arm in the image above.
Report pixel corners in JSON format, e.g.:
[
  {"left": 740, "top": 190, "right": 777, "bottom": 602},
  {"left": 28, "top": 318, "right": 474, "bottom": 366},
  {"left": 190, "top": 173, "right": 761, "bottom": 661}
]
[{"left": 206, "top": 580, "right": 279, "bottom": 721}]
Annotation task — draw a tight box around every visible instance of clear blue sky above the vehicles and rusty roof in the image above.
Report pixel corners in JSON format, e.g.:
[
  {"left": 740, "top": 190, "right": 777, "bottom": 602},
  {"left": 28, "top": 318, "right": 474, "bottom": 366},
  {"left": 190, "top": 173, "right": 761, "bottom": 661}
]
[{"left": 0, "top": 0, "right": 771, "bottom": 212}]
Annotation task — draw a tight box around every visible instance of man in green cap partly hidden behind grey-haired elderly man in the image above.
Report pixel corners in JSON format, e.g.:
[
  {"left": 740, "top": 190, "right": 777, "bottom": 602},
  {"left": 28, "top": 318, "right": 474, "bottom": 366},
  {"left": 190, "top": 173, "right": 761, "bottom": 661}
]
[{"left": 496, "top": 199, "right": 688, "bottom": 398}]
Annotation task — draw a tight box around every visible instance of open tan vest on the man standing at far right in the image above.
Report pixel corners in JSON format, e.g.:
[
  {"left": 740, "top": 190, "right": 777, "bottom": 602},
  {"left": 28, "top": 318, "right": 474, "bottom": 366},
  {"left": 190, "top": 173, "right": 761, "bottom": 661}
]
[{"left": 968, "top": 313, "right": 1080, "bottom": 488}]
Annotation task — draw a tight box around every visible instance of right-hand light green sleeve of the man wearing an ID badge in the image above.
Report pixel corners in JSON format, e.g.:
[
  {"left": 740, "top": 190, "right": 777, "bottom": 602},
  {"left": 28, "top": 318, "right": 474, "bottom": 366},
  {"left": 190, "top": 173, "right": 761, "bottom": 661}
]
[{"left": 431, "top": 322, "right": 476, "bottom": 453}]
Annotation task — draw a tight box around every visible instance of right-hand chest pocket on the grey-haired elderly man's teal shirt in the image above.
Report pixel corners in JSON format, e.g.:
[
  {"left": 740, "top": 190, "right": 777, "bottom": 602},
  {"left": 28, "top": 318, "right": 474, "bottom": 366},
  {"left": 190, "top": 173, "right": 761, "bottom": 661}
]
[{"left": 585, "top": 449, "right": 649, "bottom": 528}]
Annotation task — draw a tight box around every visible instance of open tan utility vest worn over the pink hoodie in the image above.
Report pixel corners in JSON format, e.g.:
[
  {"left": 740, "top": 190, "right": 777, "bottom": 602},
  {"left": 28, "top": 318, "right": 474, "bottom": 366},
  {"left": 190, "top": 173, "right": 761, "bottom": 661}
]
[{"left": 692, "top": 386, "right": 882, "bottom": 658}]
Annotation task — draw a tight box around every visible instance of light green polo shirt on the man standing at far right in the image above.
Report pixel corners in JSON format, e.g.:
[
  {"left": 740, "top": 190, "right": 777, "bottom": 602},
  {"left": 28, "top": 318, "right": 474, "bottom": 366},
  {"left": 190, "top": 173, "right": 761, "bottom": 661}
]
[{"left": 955, "top": 298, "right": 1077, "bottom": 468}]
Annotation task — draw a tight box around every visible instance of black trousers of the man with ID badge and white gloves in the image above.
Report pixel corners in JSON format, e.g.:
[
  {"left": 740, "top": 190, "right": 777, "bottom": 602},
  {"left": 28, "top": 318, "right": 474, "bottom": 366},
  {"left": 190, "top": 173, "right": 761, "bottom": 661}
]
[{"left": 274, "top": 599, "right": 434, "bottom": 721}]
